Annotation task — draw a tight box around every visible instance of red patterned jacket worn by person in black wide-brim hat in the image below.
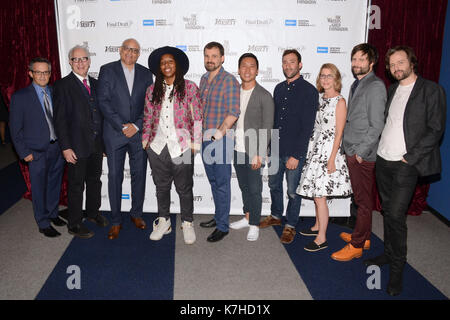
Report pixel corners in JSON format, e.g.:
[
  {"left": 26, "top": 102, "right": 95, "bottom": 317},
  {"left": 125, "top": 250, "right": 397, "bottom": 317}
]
[{"left": 142, "top": 80, "right": 203, "bottom": 150}]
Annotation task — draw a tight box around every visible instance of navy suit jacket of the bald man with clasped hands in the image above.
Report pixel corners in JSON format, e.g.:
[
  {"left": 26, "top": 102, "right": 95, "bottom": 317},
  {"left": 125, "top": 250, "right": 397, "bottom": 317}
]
[{"left": 97, "top": 60, "right": 153, "bottom": 150}]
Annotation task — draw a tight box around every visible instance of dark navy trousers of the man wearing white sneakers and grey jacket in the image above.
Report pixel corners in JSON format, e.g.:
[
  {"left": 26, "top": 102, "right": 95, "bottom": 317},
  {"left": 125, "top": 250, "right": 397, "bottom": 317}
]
[{"left": 234, "top": 151, "right": 262, "bottom": 226}]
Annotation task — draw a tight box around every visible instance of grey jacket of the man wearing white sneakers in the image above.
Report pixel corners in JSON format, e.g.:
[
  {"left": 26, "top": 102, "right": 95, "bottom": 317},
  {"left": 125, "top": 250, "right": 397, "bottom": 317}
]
[{"left": 241, "top": 83, "right": 275, "bottom": 160}]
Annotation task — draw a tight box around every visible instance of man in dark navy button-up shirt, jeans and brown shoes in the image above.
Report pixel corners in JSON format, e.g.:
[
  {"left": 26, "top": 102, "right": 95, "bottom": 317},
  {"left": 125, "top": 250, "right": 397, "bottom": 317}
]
[{"left": 260, "top": 50, "right": 319, "bottom": 244}]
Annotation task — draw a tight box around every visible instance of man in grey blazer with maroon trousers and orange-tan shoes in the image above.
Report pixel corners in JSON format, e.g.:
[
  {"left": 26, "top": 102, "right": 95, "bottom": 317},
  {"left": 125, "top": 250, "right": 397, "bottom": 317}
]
[{"left": 331, "top": 43, "right": 386, "bottom": 261}]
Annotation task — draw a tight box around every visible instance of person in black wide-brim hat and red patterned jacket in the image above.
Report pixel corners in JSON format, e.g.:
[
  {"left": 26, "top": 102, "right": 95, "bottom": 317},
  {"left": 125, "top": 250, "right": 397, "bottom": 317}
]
[{"left": 142, "top": 47, "right": 202, "bottom": 244}]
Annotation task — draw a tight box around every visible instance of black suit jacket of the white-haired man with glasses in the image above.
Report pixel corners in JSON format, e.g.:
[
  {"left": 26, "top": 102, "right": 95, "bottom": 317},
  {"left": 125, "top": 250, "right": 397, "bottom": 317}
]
[{"left": 53, "top": 72, "right": 103, "bottom": 158}]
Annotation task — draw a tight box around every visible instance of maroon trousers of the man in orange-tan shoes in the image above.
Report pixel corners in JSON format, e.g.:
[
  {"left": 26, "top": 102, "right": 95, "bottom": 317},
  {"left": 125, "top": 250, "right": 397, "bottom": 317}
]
[{"left": 346, "top": 155, "right": 375, "bottom": 248}]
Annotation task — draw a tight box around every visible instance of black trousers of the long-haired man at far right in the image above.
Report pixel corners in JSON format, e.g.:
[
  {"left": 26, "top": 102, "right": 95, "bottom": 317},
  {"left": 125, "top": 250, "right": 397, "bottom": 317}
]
[{"left": 376, "top": 157, "right": 418, "bottom": 272}]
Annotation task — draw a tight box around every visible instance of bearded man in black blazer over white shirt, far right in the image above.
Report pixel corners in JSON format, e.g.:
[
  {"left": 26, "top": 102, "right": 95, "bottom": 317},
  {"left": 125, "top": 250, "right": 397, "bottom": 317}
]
[{"left": 365, "top": 46, "right": 446, "bottom": 296}]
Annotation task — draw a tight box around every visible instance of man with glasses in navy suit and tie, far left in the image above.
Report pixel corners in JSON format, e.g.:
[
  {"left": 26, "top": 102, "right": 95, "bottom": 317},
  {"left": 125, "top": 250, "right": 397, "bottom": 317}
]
[{"left": 10, "top": 58, "right": 65, "bottom": 237}]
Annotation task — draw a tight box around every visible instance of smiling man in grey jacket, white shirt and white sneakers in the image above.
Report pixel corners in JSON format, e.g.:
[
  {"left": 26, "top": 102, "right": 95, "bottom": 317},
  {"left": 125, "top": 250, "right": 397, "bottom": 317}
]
[{"left": 230, "top": 53, "right": 275, "bottom": 241}]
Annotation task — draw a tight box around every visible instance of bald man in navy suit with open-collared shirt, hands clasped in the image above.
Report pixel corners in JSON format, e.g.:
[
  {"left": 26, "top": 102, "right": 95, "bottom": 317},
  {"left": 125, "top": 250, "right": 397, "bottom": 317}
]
[{"left": 97, "top": 39, "right": 153, "bottom": 239}]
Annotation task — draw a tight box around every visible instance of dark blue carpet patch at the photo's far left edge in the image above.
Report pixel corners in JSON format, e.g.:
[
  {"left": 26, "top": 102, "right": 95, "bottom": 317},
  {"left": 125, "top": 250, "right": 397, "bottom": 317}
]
[{"left": 0, "top": 161, "right": 27, "bottom": 214}]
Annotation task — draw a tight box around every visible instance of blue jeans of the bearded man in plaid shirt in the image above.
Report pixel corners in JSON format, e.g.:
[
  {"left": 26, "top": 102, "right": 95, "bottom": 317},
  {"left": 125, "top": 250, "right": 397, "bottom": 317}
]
[{"left": 202, "top": 136, "right": 234, "bottom": 232}]
